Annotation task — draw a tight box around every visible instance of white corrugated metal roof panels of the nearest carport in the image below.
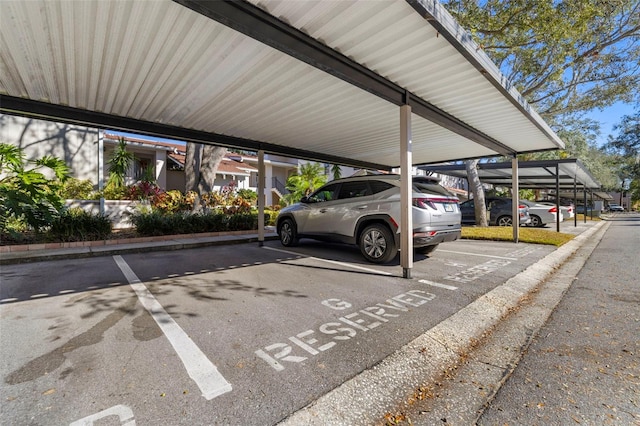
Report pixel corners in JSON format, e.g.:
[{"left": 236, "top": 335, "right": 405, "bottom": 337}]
[{"left": 0, "top": 0, "right": 558, "bottom": 167}]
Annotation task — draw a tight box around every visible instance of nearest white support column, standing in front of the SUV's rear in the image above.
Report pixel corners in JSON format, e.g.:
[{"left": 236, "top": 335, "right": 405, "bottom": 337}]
[{"left": 400, "top": 105, "right": 413, "bottom": 278}]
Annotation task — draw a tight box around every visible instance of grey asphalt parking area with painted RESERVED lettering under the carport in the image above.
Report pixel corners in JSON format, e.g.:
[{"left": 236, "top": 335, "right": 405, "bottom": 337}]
[{"left": 0, "top": 236, "right": 554, "bottom": 425}]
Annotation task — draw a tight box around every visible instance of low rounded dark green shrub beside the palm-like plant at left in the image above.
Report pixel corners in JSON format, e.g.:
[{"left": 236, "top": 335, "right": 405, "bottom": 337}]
[{"left": 47, "top": 208, "right": 111, "bottom": 241}]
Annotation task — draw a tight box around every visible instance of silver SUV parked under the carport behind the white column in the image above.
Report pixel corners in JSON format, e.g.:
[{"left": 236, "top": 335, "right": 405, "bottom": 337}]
[{"left": 277, "top": 174, "right": 461, "bottom": 263}]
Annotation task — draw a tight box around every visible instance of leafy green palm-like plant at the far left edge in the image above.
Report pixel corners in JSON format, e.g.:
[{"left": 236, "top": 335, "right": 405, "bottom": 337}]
[{"left": 0, "top": 143, "right": 69, "bottom": 232}]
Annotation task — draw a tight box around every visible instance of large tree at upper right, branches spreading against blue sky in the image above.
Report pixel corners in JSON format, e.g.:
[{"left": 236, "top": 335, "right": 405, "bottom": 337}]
[{"left": 443, "top": 0, "right": 640, "bottom": 223}]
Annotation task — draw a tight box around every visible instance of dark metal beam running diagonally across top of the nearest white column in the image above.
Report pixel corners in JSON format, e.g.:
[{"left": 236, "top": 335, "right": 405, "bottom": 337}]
[{"left": 173, "top": 0, "right": 515, "bottom": 155}]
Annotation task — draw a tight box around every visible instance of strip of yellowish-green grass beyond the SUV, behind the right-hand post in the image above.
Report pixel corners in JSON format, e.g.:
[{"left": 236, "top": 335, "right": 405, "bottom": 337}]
[{"left": 462, "top": 226, "right": 575, "bottom": 247}]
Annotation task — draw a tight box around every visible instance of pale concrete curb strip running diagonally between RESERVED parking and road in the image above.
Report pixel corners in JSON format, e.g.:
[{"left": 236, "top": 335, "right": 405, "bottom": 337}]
[{"left": 279, "top": 222, "right": 606, "bottom": 426}]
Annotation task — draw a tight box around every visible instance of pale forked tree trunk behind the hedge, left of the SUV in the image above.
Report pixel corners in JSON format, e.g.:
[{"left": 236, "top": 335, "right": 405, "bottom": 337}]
[{"left": 184, "top": 142, "right": 227, "bottom": 211}]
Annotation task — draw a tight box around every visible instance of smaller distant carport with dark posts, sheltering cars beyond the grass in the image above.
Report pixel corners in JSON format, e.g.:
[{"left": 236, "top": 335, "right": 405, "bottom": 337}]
[{"left": 422, "top": 158, "right": 600, "bottom": 232}]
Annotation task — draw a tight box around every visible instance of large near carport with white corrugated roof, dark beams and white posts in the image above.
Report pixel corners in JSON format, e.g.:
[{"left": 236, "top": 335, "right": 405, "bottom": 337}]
[{"left": 0, "top": 0, "right": 563, "bottom": 277}]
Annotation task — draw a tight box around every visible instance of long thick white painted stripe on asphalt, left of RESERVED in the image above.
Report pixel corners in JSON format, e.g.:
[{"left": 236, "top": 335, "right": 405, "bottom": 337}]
[{"left": 113, "top": 255, "right": 231, "bottom": 399}]
